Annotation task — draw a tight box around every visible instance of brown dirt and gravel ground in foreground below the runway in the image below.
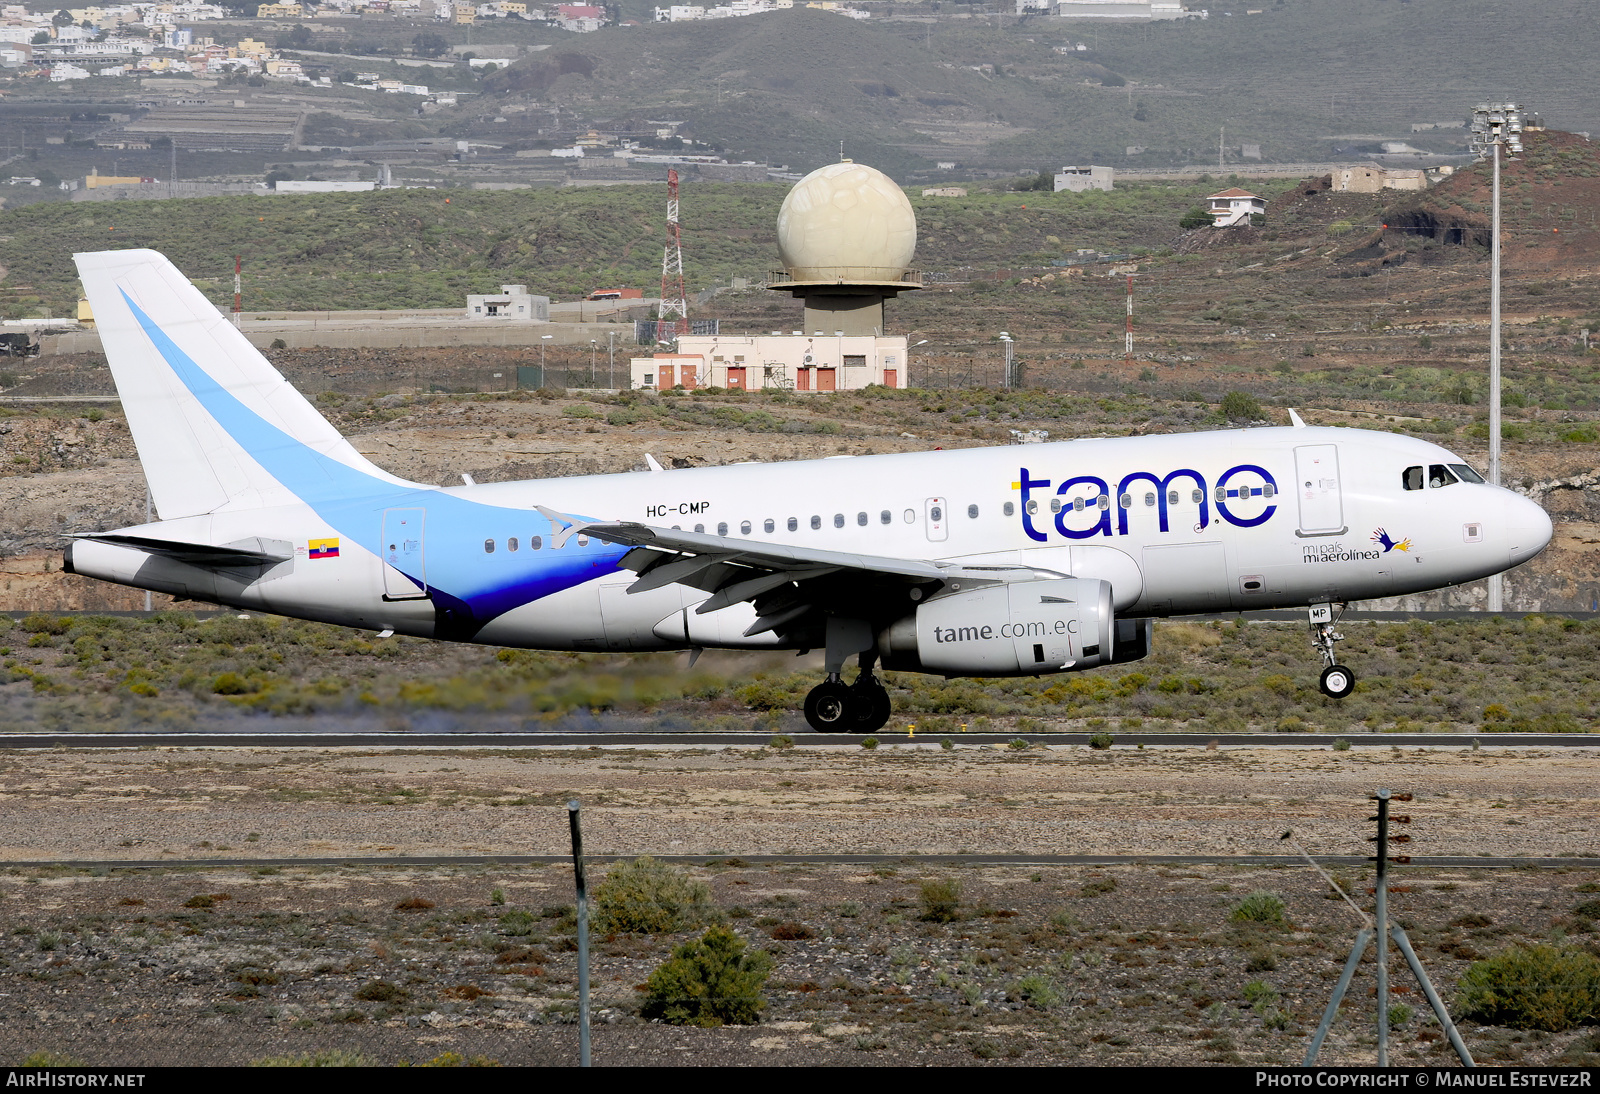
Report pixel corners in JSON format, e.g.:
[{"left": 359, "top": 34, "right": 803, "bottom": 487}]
[{"left": 0, "top": 745, "right": 1600, "bottom": 1065}]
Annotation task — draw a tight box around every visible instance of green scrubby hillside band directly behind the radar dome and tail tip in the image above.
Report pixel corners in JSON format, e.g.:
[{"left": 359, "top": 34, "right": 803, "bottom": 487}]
[{"left": 0, "top": 175, "right": 1283, "bottom": 317}]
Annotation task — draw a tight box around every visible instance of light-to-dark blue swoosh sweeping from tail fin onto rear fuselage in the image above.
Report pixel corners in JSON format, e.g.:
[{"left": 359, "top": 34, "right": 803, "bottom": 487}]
[{"left": 118, "top": 289, "right": 627, "bottom": 624}]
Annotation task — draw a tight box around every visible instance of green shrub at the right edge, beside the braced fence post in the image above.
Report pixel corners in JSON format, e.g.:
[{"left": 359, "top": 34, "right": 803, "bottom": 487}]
[{"left": 1456, "top": 945, "right": 1600, "bottom": 1033}]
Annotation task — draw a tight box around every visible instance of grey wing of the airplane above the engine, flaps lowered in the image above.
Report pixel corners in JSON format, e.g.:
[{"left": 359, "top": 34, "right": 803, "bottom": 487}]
[{"left": 539, "top": 509, "right": 1061, "bottom": 637}]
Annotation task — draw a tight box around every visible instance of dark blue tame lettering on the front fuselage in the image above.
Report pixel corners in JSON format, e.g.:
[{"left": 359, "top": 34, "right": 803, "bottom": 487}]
[{"left": 1011, "top": 464, "right": 1278, "bottom": 542}]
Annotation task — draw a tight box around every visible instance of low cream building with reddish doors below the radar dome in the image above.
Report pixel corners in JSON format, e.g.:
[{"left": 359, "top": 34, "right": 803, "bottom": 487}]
[{"left": 630, "top": 333, "right": 906, "bottom": 393}]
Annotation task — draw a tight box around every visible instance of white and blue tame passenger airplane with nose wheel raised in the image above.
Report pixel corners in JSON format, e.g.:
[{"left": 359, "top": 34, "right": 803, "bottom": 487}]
[{"left": 64, "top": 250, "right": 1552, "bottom": 733}]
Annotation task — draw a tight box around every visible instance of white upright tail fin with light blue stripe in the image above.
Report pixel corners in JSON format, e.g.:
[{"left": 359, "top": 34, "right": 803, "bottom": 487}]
[{"left": 74, "top": 250, "right": 411, "bottom": 520}]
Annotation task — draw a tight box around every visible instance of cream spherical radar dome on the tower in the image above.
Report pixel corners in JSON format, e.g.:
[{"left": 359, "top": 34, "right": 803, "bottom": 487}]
[{"left": 778, "top": 160, "right": 917, "bottom": 283}]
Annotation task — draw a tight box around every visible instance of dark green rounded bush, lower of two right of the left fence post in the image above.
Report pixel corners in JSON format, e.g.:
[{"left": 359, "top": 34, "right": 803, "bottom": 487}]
[{"left": 640, "top": 926, "right": 773, "bottom": 1027}]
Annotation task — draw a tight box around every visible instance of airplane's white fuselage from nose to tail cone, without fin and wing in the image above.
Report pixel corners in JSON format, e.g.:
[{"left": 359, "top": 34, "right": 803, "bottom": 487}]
[{"left": 70, "top": 429, "right": 1550, "bottom": 651}]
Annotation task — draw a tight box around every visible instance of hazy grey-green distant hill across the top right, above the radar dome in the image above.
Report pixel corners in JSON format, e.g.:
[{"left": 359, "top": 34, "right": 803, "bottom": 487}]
[{"left": 462, "top": 0, "right": 1600, "bottom": 181}]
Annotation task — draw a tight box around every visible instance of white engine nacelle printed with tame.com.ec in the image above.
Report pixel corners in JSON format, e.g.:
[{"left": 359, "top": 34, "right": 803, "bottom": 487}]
[{"left": 878, "top": 577, "right": 1115, "bottom": 677}]
